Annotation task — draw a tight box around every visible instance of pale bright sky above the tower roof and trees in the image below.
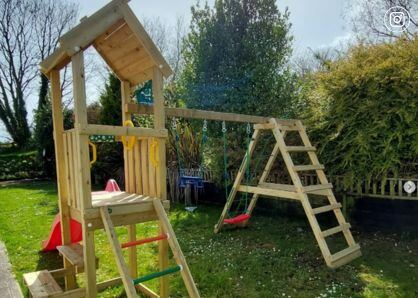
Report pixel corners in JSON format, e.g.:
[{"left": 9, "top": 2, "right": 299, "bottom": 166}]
[{"left": 0, "top": 0, "right": 350, "bottom": 141}]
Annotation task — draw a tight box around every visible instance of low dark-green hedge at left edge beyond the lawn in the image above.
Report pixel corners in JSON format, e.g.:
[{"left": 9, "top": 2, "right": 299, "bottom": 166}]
[{"left": 0, "top": 151, "right": 44, "bottom": 180}]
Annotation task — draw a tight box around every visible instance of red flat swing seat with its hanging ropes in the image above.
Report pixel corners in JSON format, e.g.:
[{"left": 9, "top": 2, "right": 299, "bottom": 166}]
[{"left": 222, "top": 121, "right": 251, "bottom": 225}]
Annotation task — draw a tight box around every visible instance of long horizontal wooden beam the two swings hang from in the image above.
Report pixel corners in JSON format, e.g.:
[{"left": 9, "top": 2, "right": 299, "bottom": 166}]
[{"left": 125, "top": 103, "right": 296, "bottom": 125}]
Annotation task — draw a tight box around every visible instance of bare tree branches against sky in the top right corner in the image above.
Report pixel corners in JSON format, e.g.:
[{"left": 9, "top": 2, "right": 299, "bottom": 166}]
[{"left": 347, "top": 0, "right": 418, "bottom": 41}]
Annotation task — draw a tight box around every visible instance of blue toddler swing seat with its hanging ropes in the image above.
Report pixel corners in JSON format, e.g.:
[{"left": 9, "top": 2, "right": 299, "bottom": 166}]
[{"left": 172, "top": 118, "right": 207, "bottom": 212}]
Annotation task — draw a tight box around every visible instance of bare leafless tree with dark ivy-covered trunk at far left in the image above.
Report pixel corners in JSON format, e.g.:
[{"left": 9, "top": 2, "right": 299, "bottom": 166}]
[{"left": 0, "top": 0, "right": 77, "bottom": 147}]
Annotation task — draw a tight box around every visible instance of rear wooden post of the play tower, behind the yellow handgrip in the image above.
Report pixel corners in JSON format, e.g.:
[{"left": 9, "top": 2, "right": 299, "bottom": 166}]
[{"left": 121, "top": 81, "right": 139, "bottom": 278}]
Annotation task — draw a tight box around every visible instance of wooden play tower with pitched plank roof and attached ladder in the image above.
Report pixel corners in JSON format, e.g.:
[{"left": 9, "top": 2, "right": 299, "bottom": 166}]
[{"left": 24, "top": 0, "right": 199, "bottom": 297}]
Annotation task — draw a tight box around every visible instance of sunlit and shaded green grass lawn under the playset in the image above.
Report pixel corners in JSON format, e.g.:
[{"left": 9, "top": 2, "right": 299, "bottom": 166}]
[{"left": 0, "top": 182, "right": 418, "bottom": 297}]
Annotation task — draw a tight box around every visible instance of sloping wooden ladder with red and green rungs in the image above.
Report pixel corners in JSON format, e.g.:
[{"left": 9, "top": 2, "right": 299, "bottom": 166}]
[{"left": 100, "top": 199, "right": 200, "bottom": 298}]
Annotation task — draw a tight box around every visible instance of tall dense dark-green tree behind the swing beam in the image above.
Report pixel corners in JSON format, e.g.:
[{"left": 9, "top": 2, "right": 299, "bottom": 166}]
[{"left": 177, "top": 0, "right": 293, "bottom": 172}]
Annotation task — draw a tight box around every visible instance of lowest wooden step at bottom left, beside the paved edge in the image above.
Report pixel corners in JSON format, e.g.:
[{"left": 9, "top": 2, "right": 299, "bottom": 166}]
[{"left": 23, "top": 270, "right": 63, "bottom": 298}]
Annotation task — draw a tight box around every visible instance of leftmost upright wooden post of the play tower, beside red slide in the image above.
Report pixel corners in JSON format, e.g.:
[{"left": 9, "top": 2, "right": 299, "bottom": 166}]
[{"left": 50, "top": 70, "right": 76, "bottom": 290}]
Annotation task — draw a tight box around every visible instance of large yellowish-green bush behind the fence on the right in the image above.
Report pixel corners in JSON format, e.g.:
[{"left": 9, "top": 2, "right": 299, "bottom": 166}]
[{"left": 303, "top": 38, "right": 418, "bottom": 180}]
